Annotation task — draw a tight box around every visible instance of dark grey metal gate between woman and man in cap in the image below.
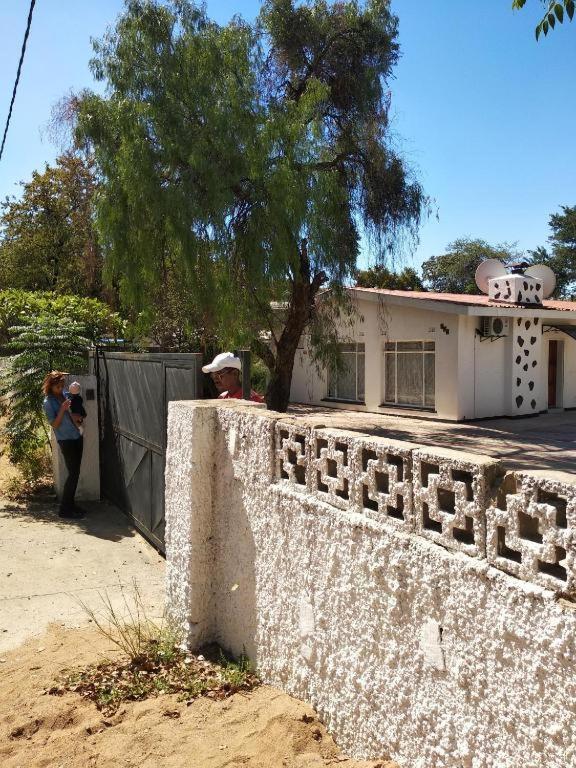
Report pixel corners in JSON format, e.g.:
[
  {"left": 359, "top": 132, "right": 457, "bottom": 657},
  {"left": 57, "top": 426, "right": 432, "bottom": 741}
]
[{"left": 91, "top": 350, "right": 202, "bottom": 552}]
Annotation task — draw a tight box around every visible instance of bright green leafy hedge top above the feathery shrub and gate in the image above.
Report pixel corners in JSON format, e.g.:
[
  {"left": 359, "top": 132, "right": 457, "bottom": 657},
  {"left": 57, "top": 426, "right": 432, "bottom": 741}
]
[{"left": 0, "top": 289, "right": 125, "bottom": 346}]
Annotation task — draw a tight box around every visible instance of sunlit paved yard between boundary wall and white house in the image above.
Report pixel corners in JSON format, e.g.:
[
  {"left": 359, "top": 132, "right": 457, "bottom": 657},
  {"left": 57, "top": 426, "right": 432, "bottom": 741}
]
[{"left": 290, "top": 405, "right": 576, "bottom": 473}]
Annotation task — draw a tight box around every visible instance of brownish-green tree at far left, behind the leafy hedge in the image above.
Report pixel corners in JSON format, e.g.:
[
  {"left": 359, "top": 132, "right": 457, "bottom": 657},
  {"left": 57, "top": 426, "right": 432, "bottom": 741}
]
[{"left": 0, "top": 152, "right": 102, "bottom": 297}]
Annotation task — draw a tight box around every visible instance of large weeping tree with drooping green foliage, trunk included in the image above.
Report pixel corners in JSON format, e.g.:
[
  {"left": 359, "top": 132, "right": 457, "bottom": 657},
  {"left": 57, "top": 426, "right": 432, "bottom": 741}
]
[{"left": 78, "top": 0, "right": 426, "bottom": 410}]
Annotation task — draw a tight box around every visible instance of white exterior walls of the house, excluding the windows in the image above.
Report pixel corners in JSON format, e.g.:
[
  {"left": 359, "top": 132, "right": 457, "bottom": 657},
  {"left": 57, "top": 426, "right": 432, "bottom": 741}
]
[{"left": 291, "top": 297, "right": 576, "bottom": 421}]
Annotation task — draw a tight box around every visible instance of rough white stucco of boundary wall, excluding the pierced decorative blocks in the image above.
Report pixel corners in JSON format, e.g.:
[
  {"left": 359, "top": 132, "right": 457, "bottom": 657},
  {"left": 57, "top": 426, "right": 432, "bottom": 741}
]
[{"left": 166, "top": 403, "right": 576, "bottom": 768}]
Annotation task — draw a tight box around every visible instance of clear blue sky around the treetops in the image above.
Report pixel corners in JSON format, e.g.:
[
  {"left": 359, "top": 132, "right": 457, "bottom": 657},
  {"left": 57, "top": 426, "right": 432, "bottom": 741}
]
[{"left": 0, "top": 0, "right": 576, "bottom": 264}]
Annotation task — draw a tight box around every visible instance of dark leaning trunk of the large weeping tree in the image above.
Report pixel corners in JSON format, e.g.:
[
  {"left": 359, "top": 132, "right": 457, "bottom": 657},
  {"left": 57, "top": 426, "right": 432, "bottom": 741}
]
[{"left": 264, "top": 240, "right": 326, "bottom": 413}]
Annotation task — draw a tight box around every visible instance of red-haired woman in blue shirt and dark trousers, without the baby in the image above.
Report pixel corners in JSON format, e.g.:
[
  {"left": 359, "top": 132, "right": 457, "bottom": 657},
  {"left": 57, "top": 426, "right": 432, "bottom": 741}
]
[{"left": 42, "top": 371, "right": 84, "bottom": 518}]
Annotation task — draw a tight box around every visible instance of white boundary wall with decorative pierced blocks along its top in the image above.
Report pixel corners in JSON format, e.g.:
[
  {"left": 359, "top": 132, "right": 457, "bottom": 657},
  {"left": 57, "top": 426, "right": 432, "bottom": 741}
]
[{"left": 166, "top": 402, "right": 576, "bottom": 768}]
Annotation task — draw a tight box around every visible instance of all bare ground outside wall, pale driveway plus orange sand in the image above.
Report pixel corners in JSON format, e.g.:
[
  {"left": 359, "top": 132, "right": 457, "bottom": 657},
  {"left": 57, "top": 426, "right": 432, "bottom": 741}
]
[{"left": 0, "top": 501, "right": 393, "bottom": 768}]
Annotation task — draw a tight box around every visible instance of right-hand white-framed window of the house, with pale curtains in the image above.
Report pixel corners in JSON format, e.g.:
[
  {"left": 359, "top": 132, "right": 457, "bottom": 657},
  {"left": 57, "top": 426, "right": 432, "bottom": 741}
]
[{"left": 384, "top": 341, "right": 436, "bottom": 408}]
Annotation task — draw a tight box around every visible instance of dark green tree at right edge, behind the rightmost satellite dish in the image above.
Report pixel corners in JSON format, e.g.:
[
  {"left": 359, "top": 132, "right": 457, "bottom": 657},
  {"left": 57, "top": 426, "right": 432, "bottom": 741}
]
[{"left": 530, "top": 205, "right": 576, "bottom": 299}]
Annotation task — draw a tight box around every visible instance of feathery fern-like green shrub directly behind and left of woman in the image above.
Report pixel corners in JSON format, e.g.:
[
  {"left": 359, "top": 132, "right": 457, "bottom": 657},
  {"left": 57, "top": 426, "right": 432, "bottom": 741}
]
[{"left": 0, "top": 315, "right": 89, "bottom": 482}]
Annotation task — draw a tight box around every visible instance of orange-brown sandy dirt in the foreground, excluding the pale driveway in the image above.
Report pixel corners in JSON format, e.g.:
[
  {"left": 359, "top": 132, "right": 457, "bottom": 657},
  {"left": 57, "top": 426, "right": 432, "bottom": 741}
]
[{"left": 0, "top": 624, "right": 396, "bottom": 768}]
